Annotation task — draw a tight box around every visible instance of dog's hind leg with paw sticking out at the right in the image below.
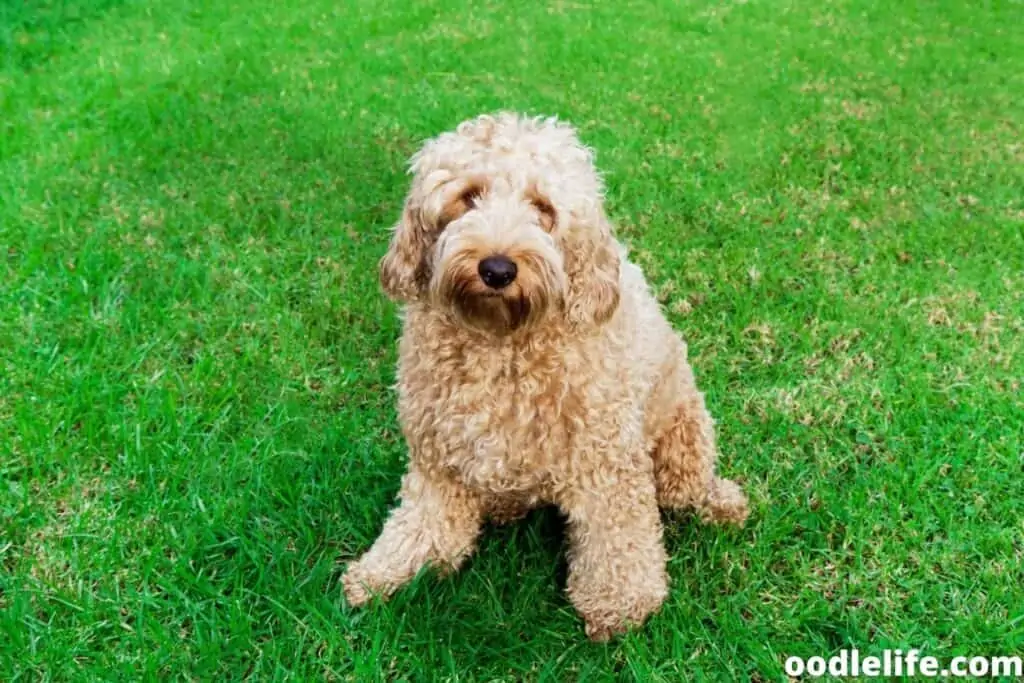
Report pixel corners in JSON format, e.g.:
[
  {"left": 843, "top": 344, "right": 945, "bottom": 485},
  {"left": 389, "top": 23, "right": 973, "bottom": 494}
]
[{"left": 651, "top": 368, "right": 749, "bottom": 524}]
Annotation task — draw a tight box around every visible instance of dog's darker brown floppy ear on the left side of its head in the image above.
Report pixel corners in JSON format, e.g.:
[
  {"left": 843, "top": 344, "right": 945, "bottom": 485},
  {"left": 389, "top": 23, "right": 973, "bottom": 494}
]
[{"left": 379, "top": 199, "right": 430, "bottom": 303}]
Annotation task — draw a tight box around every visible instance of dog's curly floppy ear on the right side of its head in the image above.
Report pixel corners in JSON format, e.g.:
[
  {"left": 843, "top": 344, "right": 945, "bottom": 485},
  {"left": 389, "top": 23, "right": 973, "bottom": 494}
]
[{"left": 565, "top": 215, "right": 620, "bottom": 326}]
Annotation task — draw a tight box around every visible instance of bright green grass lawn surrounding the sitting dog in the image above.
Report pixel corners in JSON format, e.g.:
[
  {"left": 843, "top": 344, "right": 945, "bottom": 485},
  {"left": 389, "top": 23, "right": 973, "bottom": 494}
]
[{"left": 0, "top": 0, "right": 1024, "bottom": 681}]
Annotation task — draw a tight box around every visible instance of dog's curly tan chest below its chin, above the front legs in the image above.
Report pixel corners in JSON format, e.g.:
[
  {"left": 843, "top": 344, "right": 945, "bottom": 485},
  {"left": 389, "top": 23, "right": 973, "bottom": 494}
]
[{"left": 399, "top": 339, "right": 579, "bottom": 493}]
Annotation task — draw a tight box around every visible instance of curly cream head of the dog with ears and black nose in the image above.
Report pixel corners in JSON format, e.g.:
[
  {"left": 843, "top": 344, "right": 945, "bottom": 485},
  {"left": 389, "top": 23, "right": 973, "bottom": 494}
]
[{"left": 380, "top": 114, "right": 620, "bottom": 334}]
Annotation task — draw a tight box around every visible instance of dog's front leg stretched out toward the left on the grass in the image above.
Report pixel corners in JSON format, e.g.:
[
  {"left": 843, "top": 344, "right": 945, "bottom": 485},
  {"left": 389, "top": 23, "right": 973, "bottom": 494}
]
[{"left": 342, "top": 465, "right": 483, "bottom": 606}]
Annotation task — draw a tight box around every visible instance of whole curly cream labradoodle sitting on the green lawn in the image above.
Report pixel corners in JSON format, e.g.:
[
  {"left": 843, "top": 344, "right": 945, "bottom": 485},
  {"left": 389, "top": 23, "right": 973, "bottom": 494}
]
[{"left": 343, "top": 114, "right": 748, "bottom": 640}]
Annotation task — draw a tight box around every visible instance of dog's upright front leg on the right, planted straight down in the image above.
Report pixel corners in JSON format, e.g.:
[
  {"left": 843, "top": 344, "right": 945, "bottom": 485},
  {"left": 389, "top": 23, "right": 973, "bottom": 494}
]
[{"left": 559, "top": 462, "right": 668, "bottom": 640}]
